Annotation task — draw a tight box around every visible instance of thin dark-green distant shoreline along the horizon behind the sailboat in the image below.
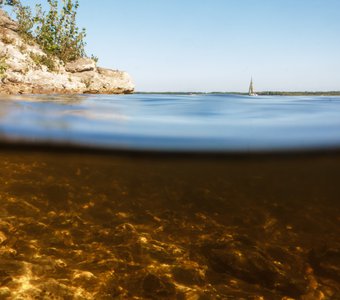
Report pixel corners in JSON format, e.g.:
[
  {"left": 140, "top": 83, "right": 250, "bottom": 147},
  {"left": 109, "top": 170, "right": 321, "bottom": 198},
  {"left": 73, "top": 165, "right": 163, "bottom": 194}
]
[{"left": 135, "top": 91, "right": 340, "bottom": 96}]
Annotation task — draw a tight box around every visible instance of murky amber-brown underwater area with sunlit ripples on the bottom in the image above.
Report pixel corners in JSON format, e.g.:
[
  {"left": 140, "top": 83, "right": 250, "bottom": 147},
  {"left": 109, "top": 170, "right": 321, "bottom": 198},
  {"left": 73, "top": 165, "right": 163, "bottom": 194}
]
[{"left": 0, "top": 151, "right": 340, "bottom": 300}]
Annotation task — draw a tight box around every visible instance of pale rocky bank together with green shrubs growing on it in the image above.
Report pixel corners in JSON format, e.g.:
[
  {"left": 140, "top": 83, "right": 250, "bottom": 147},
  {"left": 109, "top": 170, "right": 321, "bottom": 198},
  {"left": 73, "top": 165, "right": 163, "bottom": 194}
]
[{"left": 0, "top": 0, "right": 134, "bottom": 94}]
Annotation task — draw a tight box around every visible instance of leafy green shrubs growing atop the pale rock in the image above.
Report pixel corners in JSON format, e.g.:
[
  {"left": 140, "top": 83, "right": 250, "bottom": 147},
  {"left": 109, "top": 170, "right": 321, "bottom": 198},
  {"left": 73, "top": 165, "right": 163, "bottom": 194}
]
[{"left": 0, "top": 0, "right": 86, "bottom": 63}]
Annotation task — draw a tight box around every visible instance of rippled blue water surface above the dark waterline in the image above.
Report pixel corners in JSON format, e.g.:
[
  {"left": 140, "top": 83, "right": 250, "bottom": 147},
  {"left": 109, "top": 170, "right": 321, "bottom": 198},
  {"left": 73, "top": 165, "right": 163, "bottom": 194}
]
[{"left": 0, "top": 94, "right": 340, "bottom": 151}]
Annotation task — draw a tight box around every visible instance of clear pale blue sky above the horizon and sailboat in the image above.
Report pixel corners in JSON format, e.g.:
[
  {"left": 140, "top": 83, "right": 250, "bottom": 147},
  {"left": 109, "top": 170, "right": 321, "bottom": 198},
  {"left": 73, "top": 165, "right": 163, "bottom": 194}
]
[{"left": 17, "top": 0, "right": 340, "bottom": 92}]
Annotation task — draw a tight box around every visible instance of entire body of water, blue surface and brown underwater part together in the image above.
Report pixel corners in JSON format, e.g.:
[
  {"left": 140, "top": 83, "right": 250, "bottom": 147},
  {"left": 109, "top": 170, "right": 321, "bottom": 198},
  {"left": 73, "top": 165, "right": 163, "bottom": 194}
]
[{"left": 0, "top": 94, "right": 340, "bottom": 300}]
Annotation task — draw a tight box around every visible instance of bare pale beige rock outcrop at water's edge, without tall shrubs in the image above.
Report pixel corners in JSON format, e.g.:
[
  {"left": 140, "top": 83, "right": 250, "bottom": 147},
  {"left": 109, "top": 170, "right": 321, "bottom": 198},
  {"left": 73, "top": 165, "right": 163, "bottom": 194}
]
[{"left": 0, "top": 9, "right": 134, "bottom": 94}]
